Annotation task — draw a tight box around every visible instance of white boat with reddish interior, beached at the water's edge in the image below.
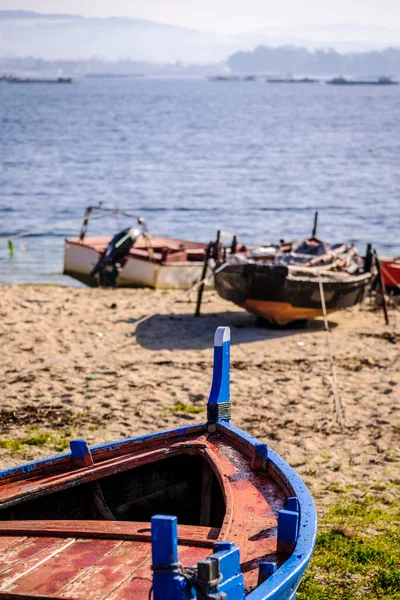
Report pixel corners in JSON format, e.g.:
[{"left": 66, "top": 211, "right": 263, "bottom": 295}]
[{"left": 63, "top": 207, "right": 207, "bottom": 289}]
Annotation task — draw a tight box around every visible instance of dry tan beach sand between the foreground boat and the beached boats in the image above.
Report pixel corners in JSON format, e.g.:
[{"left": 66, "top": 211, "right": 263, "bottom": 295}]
[{"left": 0, "top": 285, "right": 400, "bottom": 509}]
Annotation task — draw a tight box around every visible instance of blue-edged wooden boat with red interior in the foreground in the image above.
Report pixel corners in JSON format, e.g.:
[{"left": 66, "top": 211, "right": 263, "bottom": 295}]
[{"left": 0, "top": 328, "right": 316, "bottom": 600}]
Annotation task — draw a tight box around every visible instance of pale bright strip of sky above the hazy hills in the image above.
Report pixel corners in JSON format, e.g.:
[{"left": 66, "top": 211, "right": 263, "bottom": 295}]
[{"left": 0, "top": 0, "right": 400, "bottom": 33}]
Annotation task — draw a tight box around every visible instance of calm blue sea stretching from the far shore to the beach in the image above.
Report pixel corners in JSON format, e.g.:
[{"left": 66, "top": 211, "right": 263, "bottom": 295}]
[{"left": 0, "top": 78, "right": 400, "bottom": 285}]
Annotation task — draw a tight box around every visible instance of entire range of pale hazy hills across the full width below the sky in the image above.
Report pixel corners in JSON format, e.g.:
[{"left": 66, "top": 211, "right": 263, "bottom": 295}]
[{"left": 0, "top": 11, "right": 400, "bottom": 63}]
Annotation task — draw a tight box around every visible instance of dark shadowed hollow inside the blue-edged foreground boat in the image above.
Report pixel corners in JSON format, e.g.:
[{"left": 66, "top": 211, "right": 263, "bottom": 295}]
[{"left": 0, "top": 454, "right": 225, "bottom": 528}]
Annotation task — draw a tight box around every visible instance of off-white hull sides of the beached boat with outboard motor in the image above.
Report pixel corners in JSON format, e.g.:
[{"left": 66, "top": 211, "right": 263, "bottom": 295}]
[{"left": 63, "top": 240, "right": 208, "bottom": 289}]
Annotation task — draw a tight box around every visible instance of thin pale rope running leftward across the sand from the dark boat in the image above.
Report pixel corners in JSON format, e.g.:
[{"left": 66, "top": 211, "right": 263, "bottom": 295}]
[{"left": 0, "top": 263, "right": 226, "bottom": 383}]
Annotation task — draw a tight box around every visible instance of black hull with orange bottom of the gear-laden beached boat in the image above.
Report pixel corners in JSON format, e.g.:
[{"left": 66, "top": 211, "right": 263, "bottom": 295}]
[{"left": 215, "top": 264, "right": 371, "bottom": 325}]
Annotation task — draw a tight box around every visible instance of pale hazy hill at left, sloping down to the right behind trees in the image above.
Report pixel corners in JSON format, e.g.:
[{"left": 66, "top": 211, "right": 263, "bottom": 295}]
[{"left": 0, "top": 11, "right": 241, "bottom": 62}]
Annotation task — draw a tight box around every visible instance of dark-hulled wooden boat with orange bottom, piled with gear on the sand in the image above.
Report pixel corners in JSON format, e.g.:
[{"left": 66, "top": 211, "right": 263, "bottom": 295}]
[{"left": 215, "top": 238, "right": 371, "bottom": 325}]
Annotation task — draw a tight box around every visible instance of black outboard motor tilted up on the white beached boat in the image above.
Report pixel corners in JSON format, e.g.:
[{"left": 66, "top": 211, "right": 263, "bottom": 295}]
[{"left": 90, "top": 227, "right": 141, "bottom": 287}]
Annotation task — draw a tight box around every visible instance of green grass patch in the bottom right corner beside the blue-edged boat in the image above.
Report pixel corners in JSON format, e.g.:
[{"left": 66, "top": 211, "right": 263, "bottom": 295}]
[{"left": 297, "top": 480, "right": 400, "bottom": 600}]
